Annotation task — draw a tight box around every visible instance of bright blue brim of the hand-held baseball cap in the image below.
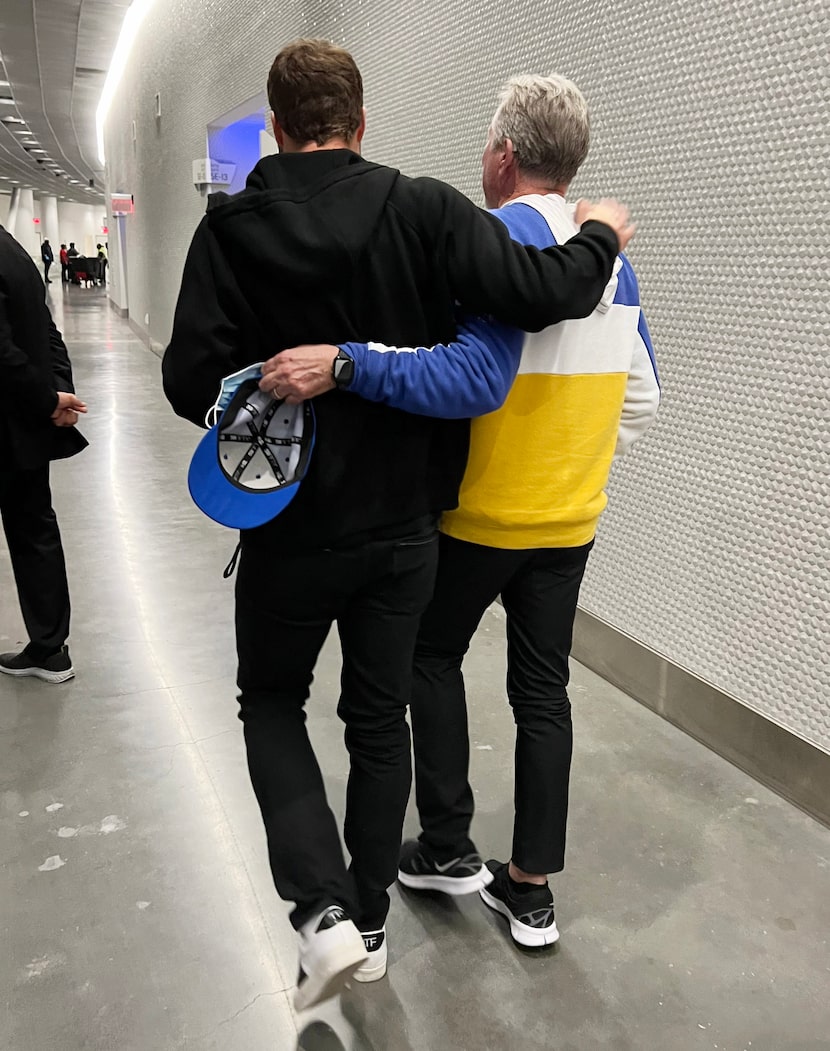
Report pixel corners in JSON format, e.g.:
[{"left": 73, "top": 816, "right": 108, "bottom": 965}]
[{"left": 187, "top": 424, "right": 299, "bottom": 529}]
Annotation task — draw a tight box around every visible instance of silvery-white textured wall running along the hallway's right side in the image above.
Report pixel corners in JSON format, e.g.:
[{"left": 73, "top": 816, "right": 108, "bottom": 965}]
[{"left": 107, "top": 0, "right": 830, "bottom": 747}]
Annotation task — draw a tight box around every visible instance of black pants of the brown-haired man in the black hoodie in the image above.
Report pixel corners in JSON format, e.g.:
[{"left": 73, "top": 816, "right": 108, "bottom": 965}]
[{"left": 236, "top": 528, "right": 438, "bottom": 930}]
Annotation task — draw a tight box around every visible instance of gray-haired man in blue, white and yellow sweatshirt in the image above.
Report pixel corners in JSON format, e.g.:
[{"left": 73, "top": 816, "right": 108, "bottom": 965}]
[{"left": 267, "top": 77, "right": 660, "bottom": 947}]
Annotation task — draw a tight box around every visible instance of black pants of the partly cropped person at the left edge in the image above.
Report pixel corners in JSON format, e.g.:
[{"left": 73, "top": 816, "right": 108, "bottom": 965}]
[{"left": 0, "top": 465, "right": 69, "bottom": 660}]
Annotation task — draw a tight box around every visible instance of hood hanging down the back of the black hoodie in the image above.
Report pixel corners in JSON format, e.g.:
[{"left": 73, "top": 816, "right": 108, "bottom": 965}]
[{"left": 208, "top": 149, "right": 399, "bottom": 294}]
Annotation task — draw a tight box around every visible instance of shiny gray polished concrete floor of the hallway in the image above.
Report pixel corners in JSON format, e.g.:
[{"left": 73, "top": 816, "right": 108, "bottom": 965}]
[{"left": 0, "top": 285, "right": 830, "bottom": 1051}]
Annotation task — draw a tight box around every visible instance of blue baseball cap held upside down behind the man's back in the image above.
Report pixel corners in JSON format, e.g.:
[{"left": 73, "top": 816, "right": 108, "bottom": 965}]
[{"left": 187, "top": 379, "right": 315, "bottom": 529}]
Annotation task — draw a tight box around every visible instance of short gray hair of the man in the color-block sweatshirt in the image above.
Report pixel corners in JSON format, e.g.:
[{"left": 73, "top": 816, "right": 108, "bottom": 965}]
[{"left": 491, "top": 74, "right": 589, "bottom": 184}]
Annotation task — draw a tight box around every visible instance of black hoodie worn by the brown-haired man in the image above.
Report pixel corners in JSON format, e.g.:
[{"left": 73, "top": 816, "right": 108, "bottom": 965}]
[{"left": 163, "top": 149, "right": 618, "bottom": 551}]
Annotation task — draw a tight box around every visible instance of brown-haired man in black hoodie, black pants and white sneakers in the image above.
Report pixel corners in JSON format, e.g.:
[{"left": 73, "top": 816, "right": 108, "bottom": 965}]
[{"left": 163, "top": 40, "right": 631, "bottom": 1009}]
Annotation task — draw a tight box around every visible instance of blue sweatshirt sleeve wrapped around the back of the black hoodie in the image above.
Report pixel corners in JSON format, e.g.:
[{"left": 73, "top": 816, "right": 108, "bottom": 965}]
[{"left": 340, "top": 316, "right": 524, "bottom": 419}]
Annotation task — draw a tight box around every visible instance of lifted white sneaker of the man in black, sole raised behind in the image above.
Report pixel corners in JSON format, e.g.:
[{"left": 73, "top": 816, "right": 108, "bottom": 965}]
[{"left": 294, "top": 905, "right": 368, "bottom": 1011}]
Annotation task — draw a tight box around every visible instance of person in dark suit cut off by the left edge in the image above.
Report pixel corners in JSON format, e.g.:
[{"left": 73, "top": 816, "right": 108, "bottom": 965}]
[{"left": 0, "top": 227, "right": 86, "bottom": 682}]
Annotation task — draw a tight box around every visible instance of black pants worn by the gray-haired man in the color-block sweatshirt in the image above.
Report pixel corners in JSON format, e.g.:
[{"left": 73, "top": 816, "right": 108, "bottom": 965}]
[{"left": 412, "top": 535, "right": 593, "bottom": 873}]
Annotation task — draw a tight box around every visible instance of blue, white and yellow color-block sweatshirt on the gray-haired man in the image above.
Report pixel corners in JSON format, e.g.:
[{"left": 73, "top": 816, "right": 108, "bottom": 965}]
[{"left": 344, "top": 194, "right": 660, "bottom": 550}]
